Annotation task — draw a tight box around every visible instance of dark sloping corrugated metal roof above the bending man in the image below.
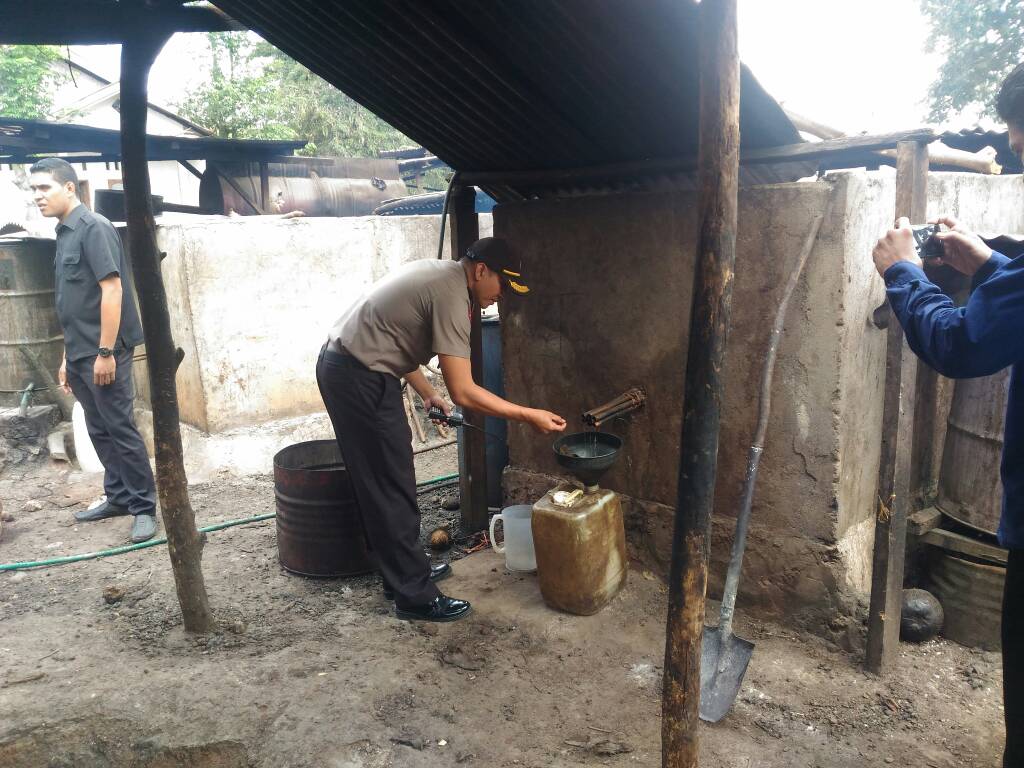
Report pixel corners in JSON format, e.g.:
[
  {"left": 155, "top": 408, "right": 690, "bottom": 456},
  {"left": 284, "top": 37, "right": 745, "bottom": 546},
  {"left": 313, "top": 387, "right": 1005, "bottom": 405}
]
[{"left": 216, "top": 0, "right": 804, "bottom": 198}]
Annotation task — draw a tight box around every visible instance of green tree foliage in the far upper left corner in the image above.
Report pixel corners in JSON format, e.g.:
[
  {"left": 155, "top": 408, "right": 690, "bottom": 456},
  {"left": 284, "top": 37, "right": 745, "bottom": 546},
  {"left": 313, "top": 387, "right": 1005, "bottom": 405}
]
[{"left": 0, "top": 45, "right": 63, "bottom": 120}]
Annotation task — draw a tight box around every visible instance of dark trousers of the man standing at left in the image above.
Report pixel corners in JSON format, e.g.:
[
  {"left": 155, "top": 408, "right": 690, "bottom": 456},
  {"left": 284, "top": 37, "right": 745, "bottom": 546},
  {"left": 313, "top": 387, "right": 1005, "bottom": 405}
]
[{"left": 68, "top": 349, "right": 157, "bottom": 515}]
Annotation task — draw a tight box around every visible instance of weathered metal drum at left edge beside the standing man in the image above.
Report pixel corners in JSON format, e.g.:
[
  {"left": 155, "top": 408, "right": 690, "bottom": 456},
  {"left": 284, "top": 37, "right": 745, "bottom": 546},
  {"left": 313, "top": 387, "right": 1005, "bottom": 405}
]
[{"left": 0, "top": 238, "right": 63, "bottom": 406}]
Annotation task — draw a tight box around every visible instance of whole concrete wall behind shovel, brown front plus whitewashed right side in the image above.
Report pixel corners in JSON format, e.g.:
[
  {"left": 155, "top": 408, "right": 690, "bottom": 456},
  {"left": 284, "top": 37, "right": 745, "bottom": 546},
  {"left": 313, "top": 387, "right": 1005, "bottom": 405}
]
[{"left": 495, "top": 172, "right": 1024, "bottom": 630}]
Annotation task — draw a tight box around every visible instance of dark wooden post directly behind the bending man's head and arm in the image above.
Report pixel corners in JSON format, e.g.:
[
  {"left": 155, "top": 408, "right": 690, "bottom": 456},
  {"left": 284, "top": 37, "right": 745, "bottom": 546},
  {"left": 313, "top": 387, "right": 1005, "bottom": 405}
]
[{"left": 451, "top": 184, "right": 487, "bottom": 532}]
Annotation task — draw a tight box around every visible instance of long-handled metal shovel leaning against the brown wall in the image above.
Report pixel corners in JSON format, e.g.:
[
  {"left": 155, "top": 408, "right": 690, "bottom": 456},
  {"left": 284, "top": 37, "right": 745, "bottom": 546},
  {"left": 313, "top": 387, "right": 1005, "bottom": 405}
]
[{"left": 699, "top": 214, "right": 824, "bottom": 723}]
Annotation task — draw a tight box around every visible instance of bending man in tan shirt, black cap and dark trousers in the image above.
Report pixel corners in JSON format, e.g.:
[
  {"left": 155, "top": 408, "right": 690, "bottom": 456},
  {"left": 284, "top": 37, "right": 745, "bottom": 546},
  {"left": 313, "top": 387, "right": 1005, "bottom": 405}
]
[{"left": 316, "top": 238, "right": 565, "bottom": 622}]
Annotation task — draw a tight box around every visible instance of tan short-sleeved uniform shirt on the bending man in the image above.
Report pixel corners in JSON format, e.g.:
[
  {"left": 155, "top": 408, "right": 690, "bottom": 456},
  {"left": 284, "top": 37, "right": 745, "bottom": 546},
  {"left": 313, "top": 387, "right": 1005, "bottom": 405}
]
[{"left": 329, "top": 259, "right": 470, "bottom": 378}]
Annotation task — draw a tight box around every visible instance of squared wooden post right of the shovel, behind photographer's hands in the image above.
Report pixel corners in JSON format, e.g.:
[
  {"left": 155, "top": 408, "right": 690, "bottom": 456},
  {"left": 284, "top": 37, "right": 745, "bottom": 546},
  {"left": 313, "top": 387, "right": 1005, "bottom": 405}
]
[{"left": 864, "top": 141, "right": 928, "bottom": 675}]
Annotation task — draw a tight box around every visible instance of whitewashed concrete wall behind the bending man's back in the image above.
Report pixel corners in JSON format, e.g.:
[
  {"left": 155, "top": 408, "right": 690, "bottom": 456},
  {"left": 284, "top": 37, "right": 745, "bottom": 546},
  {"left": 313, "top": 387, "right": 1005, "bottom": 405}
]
[{"left": 151, "top": 215, "right": 490, "bottom": 432}]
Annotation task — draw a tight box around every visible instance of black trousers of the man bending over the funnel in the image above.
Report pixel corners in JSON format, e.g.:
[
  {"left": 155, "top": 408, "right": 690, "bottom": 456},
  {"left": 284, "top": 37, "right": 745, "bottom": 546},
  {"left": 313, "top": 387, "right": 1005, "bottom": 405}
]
[{"left": 316, "top": 347, "right": 439, "bottom": 608}]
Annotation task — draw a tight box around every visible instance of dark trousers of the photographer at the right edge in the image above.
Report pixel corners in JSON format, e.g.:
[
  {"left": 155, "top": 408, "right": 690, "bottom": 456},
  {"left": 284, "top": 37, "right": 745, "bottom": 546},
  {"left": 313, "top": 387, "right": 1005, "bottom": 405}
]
[{"left": 1002, "top": 549, "right": 1024, "bottom": 768}]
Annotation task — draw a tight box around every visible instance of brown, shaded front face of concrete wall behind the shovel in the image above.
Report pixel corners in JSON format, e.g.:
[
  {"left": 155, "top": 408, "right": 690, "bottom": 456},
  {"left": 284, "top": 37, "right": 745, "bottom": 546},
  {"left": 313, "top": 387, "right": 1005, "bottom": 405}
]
[{"left": 495, "top": 183, "right": 844, "bottom": 634}]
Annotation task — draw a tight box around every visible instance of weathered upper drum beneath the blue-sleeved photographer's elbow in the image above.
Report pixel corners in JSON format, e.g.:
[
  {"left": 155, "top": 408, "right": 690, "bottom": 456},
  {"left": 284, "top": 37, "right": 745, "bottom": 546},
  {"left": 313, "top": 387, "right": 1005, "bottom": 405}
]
[{"left": 938, "top": 369, "right": 1010, "bottom": 535}]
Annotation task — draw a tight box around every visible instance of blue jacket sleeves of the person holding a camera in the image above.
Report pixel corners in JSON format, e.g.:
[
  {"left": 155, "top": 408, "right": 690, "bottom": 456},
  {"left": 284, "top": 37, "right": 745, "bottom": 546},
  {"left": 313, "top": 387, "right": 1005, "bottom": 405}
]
[{"left": 885, "top": 253, "right": 1024, "bottom": 379}]
